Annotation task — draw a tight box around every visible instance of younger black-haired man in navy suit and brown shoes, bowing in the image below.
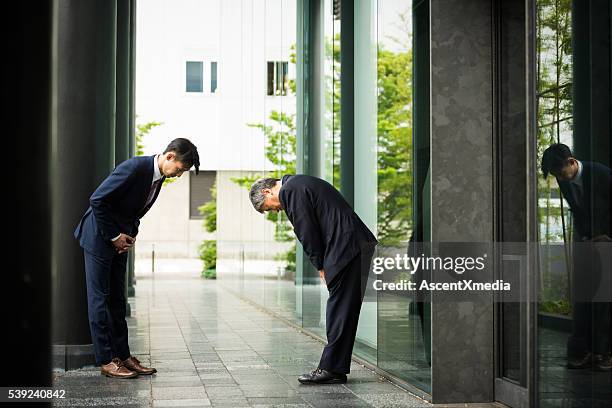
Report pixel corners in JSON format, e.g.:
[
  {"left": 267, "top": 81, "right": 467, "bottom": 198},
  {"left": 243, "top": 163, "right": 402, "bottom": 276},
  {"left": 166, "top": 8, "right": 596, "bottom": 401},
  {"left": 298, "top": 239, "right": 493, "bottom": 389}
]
[{"left": 74, "top": 139, "right": 200, "bottom": 378}]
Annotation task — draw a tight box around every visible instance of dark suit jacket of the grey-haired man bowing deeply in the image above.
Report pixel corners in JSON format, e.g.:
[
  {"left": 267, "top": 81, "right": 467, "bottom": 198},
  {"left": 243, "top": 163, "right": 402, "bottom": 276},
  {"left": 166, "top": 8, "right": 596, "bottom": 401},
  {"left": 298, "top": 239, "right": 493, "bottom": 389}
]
[{"left": 279, "top": 174, "right": 378, "bottom": 285}]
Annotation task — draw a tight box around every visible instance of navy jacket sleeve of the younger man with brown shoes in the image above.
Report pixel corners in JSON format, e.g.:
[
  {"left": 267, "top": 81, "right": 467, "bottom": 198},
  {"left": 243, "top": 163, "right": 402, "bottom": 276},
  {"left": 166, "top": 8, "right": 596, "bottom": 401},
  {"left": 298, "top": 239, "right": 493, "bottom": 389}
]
[{"left": 89, "top": 161, "right": 136, "bottom": 241}]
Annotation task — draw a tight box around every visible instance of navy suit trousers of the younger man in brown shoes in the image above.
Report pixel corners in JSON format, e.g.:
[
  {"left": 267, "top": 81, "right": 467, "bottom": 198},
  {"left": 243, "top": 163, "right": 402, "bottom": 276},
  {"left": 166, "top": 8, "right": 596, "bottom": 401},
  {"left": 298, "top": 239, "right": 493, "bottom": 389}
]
[{"left": 85, "top": 250, "right": 130, "bottom": 365}]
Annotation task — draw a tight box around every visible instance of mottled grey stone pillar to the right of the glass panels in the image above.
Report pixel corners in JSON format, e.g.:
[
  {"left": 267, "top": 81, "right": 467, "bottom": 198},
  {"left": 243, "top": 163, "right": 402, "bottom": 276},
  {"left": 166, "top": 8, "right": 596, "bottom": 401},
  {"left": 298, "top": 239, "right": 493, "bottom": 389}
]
[{"left": 430, "top": 0, "right": 494, "bottom": 403}]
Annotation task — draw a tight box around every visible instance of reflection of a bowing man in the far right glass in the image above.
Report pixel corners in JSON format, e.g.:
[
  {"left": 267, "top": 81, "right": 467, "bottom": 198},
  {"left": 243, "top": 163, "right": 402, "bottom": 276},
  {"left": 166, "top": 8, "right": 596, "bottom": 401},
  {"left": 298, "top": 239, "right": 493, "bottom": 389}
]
[{"left": 542, "top": 143, "right": 612, "bottom": 371}]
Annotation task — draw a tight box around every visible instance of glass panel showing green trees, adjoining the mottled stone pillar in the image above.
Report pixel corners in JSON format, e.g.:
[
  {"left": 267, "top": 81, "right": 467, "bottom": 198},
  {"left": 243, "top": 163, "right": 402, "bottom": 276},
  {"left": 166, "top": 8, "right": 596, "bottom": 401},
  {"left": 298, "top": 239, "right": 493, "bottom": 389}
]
[{"left": 376, "top": 0, "right": 431, "bottom": 392}]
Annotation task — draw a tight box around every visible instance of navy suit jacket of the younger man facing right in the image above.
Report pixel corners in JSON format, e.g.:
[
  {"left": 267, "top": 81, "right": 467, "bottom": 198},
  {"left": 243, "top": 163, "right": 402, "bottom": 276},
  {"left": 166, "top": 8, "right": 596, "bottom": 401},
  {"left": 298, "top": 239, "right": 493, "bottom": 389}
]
[{"left": 74, "top": 156, "right": 164, "bottom": 257}]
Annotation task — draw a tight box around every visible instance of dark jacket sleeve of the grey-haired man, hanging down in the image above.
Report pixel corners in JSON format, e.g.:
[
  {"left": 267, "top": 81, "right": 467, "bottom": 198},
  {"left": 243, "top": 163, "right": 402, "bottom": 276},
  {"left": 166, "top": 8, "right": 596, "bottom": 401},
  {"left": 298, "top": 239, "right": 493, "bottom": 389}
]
[{"left": 283, "top": 191, "right": 325, "bottom": 270}]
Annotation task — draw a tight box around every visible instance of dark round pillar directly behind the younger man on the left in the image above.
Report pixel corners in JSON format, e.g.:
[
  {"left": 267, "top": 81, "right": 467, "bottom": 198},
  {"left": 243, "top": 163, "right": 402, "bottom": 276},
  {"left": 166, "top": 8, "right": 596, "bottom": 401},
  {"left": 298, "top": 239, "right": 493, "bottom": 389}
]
[{"left": 53, "top": 0, "right": 117, "bottom": 369}]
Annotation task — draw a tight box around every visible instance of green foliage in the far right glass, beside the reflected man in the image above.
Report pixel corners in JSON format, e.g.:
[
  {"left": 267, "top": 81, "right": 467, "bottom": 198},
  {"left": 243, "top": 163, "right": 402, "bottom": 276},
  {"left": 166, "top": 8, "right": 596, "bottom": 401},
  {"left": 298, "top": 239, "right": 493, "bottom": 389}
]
[{"left": 536, "top": 0, "right": 573, "bottom": 315}]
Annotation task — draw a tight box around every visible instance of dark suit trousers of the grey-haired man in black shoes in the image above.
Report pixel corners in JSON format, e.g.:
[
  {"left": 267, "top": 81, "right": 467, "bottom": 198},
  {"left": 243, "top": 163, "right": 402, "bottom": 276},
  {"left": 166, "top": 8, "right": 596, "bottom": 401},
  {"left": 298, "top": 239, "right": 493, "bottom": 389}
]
[{"left": 319, "top": 249, "right": 374, "bottom": 374}]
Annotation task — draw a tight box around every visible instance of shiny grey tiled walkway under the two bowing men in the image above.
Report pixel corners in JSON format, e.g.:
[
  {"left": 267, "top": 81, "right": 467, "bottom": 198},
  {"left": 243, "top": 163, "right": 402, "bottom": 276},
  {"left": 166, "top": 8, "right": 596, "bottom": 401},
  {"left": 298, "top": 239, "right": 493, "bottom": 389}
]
[{"left": 54, "top": 275, "right": 431, "bottom": 408}]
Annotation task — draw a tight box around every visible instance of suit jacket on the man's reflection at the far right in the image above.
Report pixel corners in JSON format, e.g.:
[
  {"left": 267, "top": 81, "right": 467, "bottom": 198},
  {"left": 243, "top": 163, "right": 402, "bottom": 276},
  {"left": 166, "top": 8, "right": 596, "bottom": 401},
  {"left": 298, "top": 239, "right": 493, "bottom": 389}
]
[{"left": 558, "top": 161, "right": 612, "bottom": 241}]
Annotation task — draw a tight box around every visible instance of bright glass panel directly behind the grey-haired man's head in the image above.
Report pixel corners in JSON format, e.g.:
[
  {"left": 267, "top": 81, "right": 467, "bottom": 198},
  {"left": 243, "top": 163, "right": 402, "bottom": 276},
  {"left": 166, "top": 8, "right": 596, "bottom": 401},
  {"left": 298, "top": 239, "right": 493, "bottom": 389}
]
[{"left": 264, "top": 0, "right": 301, "bottom": 323}]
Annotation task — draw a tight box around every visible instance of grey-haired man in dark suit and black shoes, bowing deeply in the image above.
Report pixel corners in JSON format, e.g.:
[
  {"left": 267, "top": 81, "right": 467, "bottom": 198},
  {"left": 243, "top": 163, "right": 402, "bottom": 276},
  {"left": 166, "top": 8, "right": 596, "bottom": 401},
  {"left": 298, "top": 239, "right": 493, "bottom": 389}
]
[{"left": 250, "top": 175, "right": 378, "bottom": 384}]
